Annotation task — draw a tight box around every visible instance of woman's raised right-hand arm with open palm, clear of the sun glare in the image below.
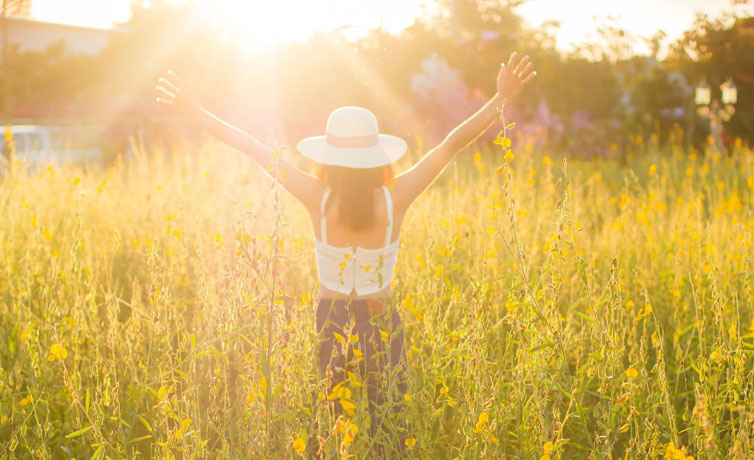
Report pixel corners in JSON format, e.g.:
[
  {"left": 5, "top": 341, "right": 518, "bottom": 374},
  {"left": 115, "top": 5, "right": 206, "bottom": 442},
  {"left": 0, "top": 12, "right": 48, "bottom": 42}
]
[{"left": 393, "top": 52, "right": 537, "bottom": 212}]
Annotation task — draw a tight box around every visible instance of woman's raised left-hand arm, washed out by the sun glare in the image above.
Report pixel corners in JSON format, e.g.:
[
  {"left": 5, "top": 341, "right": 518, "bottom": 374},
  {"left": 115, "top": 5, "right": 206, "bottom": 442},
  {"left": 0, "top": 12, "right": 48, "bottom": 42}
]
[{"left": 157, "top": 71, "right": 322, "bottom": 214}]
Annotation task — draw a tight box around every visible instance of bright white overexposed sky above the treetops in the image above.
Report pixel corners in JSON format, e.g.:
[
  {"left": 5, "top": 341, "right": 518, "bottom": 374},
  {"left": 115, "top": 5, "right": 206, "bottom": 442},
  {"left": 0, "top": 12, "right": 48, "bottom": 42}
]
[{"left": 31, "top": 0, "right": 754, "bottom": 53}]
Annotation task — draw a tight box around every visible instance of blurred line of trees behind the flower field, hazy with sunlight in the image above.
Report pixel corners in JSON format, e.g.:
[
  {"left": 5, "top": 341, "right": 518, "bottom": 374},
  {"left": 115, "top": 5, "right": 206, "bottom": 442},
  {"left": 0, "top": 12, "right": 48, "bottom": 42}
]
[{"left": 3, "top": 0, "right": 754, "bottom": 155}]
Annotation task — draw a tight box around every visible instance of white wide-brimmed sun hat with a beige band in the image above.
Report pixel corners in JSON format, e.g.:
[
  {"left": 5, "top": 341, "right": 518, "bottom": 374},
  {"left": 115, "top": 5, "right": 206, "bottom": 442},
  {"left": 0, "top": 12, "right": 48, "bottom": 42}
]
[{"left": 296, "top": 106, "right": 407, "bottom": 169}]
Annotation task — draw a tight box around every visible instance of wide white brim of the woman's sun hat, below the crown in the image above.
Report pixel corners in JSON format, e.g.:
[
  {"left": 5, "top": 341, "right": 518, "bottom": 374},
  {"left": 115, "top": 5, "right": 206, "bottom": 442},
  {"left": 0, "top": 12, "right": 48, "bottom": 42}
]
[{"left": 296, "top": 134, "right": 408, "bottom": 169}]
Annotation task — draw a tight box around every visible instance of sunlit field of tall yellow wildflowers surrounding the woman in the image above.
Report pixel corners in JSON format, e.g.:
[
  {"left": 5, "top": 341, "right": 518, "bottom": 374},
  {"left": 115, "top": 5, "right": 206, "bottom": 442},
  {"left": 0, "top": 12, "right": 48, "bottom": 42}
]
[{"left": 0, "top": 130, "right": 754, "bottom": 460}]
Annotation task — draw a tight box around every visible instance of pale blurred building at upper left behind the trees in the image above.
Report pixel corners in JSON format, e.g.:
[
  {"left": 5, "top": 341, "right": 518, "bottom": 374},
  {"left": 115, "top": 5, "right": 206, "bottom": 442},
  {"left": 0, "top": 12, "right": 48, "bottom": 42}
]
[{"left": 0, "top": 18, "right": 126, "bottom": 55}]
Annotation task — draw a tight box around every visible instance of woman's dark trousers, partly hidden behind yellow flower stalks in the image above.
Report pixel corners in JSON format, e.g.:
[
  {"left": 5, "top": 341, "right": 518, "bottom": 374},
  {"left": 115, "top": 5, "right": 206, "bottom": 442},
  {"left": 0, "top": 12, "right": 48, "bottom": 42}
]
[{"left": 317, "top": 299, "right": 407, "bottom": 452}]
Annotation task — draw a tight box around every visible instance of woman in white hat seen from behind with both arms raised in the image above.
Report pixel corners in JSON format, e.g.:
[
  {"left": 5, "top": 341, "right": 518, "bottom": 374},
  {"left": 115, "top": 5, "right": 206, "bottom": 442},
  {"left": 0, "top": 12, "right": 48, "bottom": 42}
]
[{"left": 157, "top": 53, "right": 536, "bottom": 456}]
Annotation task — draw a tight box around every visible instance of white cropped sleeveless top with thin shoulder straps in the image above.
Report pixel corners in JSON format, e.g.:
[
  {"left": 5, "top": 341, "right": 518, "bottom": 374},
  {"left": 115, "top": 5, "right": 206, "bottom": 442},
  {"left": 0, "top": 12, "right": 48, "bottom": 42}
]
[{"left": 314, "top": 185, "right": 400, "bottom": 296}]
